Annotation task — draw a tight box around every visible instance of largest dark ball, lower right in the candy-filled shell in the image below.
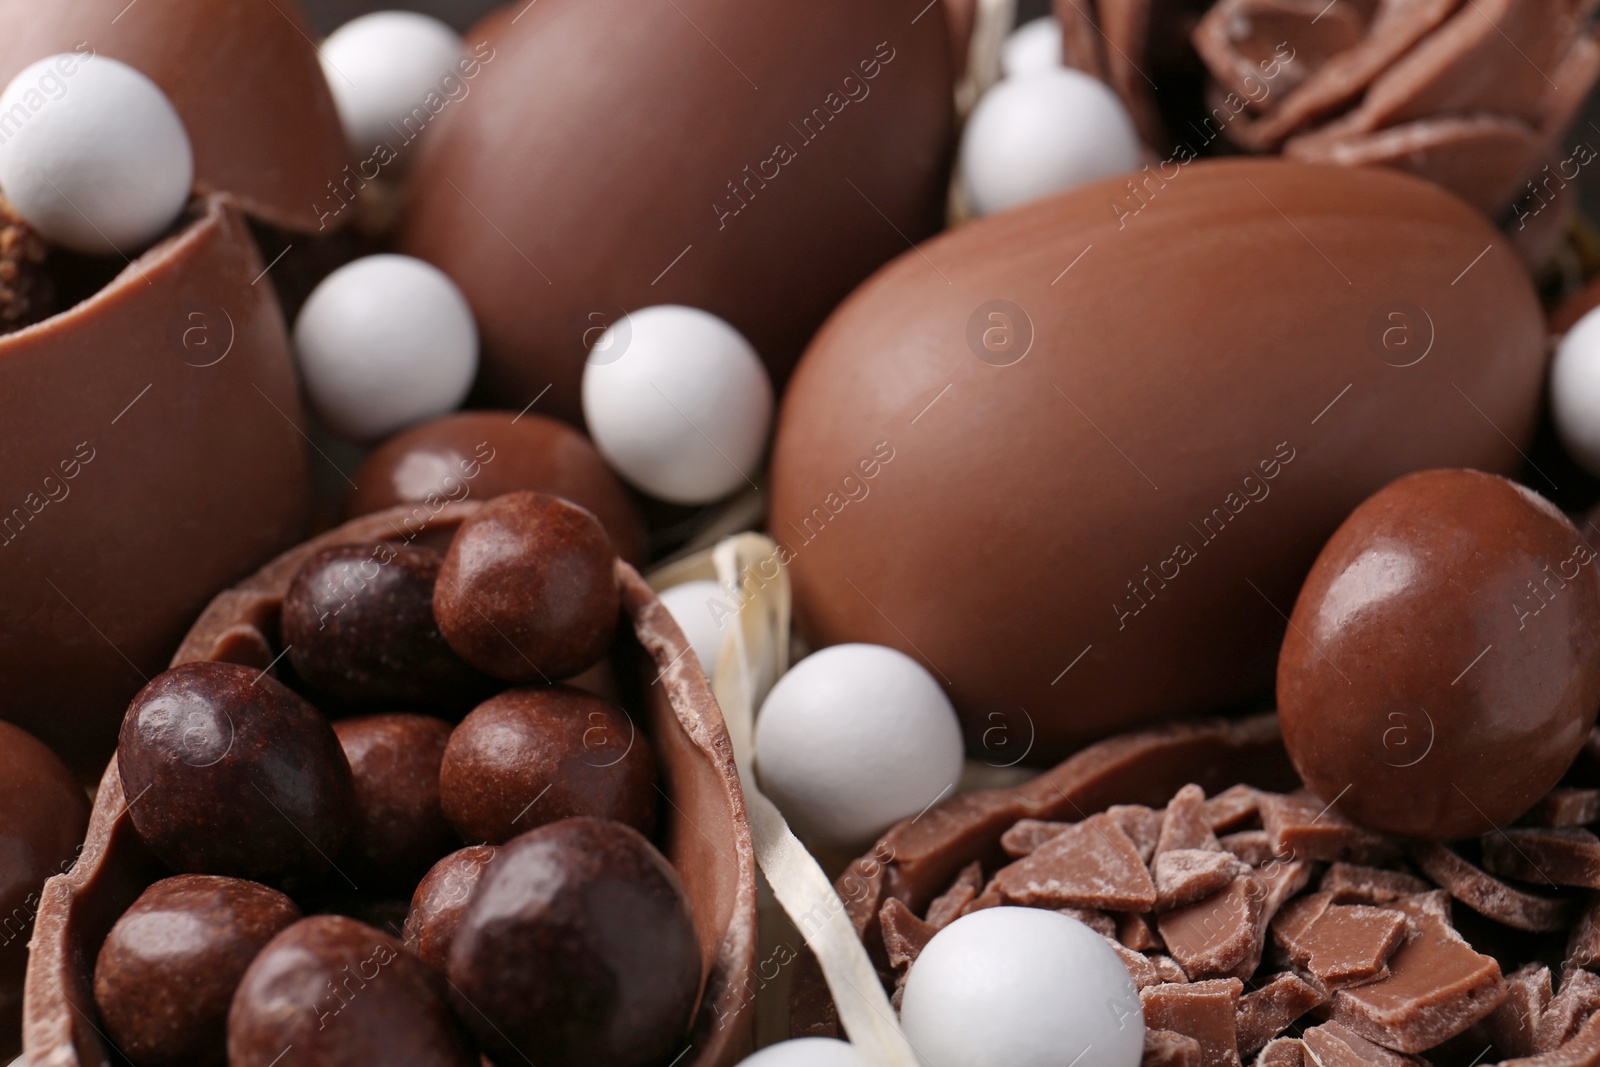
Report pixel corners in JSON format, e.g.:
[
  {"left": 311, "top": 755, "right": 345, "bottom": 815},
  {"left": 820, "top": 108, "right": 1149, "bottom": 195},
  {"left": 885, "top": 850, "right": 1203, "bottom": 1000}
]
[{"left": 450, "top": 819, "right": 701, "bottom": 1067}]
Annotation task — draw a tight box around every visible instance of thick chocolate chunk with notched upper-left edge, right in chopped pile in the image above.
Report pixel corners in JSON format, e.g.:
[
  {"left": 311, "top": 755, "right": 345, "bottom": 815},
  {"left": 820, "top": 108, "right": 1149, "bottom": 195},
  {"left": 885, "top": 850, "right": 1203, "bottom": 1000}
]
[{"left": 1333, "top": 913, "right": 1506, "bottom": 1053}]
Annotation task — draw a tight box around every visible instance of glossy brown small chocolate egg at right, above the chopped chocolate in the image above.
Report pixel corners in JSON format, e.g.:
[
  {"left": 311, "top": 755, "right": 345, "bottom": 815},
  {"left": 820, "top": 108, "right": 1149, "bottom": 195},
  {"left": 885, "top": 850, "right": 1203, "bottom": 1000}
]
[{"left": 1278, "top": 470, "right": 1600, "bottom": 840}]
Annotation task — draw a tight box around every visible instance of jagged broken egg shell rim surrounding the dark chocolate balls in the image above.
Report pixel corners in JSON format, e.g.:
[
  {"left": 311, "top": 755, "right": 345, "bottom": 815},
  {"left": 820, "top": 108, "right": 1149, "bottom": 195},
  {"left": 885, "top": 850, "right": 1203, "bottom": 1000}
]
[{"left": 22, "top": 502, "right": 755, "bottom": 1067}]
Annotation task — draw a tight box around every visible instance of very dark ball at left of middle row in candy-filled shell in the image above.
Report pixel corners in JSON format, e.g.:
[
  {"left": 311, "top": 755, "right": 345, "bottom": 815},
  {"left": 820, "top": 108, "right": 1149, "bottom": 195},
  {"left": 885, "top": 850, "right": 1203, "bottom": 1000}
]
[{"left": 117, "top": 662, "right": 355, "bottom": 883}]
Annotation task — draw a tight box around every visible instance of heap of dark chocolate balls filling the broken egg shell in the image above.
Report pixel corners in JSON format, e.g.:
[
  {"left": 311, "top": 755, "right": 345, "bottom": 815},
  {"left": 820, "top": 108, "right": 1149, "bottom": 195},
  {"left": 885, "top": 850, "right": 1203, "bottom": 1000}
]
[{"left": 94, "top": 493, "right": 701, "bottom": 1067}]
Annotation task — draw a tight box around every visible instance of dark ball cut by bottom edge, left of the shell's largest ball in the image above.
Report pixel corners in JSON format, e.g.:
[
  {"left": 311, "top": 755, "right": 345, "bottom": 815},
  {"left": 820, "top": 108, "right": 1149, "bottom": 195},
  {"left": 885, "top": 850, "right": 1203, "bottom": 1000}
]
[{"left": 227, "top": 915, "right": 478, "bottom": 1067}]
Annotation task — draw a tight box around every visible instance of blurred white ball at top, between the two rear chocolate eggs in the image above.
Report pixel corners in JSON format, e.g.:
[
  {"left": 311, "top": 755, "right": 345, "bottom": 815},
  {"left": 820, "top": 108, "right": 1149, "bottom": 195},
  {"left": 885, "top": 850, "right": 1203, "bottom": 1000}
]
[{"left": 322, "top": 11, "right": 462, "bottom": 154}]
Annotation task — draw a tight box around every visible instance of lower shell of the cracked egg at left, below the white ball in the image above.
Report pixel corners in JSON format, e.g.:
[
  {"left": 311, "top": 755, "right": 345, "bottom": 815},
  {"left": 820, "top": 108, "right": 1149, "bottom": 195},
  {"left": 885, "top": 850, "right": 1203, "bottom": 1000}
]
[{"left": 0, "top": 191, "right": 310, "bottom": 779}]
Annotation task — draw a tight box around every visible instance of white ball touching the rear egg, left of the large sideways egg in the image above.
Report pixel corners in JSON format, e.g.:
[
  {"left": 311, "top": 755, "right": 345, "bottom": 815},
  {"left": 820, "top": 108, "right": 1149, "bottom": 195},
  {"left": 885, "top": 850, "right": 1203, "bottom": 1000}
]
[{"left": 582, "top": 304, "right": 773, "bottom": 504}]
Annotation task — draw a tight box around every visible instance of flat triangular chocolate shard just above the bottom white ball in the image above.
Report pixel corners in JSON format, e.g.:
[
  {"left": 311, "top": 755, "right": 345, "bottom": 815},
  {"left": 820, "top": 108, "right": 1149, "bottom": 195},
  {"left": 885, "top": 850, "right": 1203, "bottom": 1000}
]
[{"left": 992, "top": 814, "right": 1155, "bottom": 912}]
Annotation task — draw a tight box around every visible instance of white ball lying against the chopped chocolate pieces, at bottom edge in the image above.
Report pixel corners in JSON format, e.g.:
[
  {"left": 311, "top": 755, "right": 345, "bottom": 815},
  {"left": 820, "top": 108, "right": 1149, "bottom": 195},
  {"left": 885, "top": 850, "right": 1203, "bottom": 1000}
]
[{"left": 901, "top": 907, "right": 1144, "bottom": 1067}]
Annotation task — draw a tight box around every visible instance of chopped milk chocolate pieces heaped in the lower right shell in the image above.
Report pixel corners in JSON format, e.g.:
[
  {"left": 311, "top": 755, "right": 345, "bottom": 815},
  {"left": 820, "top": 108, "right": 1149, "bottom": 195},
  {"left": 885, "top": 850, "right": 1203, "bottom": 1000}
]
[{"left": 878, "top": 755, "right": 1600, "bottom": 1067}]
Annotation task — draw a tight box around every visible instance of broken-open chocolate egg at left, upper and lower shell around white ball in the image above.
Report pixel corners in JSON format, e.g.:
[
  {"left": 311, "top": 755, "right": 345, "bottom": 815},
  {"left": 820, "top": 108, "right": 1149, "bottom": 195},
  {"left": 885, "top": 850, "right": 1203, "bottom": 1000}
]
[{"left": 0, "top": 0, "right": 344, "bottom": 776}]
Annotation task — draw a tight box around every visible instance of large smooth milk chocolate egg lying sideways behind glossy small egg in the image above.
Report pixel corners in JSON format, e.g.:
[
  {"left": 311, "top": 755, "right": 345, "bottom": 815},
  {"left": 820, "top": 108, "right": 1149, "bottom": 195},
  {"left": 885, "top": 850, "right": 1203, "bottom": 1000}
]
[{"left": 771, "top": 160, "right": 1544, "bottom": 763}]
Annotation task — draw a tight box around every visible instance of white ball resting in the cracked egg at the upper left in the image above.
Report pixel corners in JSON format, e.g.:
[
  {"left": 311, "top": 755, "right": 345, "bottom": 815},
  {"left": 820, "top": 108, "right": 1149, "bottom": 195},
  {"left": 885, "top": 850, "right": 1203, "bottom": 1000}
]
[{"left": 0, "top": 53, "right": 194, "bottom": 256}]
